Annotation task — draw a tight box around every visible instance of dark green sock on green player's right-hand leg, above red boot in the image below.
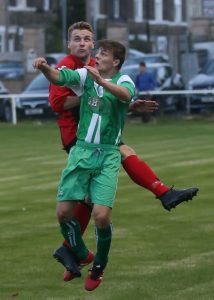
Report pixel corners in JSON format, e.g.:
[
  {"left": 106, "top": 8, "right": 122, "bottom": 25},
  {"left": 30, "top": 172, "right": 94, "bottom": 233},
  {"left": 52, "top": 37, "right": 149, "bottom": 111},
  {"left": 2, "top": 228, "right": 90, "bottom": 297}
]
[{"left": 94, "top": 224, "right": 112, "bottom": 267}]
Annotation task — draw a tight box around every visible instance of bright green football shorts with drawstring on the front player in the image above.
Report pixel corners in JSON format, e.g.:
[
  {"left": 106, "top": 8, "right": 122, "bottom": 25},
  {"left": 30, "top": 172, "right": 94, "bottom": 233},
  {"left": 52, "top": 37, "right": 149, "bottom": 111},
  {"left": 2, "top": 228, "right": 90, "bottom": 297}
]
[{"left": 57, "top": 141, "right": 121, "bottom": 207}]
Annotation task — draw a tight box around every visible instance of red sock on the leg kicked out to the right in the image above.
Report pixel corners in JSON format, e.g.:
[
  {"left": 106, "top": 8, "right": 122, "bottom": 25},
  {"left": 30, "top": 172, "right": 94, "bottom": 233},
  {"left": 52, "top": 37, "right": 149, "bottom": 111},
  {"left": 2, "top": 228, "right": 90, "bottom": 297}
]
[{"left": 122, "top": 155, "right": 170, "bottom": 197}]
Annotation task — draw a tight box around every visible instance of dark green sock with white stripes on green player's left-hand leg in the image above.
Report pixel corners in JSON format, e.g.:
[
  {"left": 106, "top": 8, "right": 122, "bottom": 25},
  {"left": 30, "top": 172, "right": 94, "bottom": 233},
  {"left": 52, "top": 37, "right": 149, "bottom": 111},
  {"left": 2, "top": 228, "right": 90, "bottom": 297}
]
[{"left": 60, "top": 219, "right": 88, "bottom": 260}]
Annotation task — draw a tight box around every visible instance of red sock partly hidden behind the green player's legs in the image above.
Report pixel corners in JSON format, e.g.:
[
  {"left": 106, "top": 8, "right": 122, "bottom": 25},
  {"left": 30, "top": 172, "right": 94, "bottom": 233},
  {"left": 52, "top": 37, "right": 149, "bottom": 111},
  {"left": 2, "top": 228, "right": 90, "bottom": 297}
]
[{"left": 63, "top": 202, "right": 92, "bottom": 248}]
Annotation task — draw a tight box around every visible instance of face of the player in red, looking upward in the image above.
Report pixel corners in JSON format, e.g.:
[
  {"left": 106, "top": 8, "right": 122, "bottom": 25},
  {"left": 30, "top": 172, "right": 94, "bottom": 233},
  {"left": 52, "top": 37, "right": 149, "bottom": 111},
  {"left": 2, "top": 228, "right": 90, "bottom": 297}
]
[{"left": 68, "top": 29, "right": 94, "bottom": 61}]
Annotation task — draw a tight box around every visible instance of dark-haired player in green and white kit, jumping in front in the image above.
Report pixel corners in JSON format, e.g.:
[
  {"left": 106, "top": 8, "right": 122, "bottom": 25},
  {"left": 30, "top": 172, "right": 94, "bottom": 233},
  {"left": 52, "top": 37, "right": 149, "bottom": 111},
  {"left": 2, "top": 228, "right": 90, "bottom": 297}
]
[{"left": 34, "top": 40, "right": 135, "bottom": 291}]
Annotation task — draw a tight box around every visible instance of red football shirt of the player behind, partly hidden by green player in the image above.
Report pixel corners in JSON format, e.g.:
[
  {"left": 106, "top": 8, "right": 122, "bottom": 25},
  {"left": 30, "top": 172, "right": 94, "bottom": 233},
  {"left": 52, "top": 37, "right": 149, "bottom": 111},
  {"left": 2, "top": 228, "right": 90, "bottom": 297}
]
[{"left": 49, "top": 54, "right": 95, "bottom": 147}]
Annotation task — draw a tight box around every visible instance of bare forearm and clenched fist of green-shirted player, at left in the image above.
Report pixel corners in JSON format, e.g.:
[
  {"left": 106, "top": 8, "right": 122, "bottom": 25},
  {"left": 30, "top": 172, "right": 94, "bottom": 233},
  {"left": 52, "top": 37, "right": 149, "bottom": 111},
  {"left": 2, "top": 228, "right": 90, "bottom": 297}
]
[{"left": 33, "top": 57, "right": 59, "bottom": 84}]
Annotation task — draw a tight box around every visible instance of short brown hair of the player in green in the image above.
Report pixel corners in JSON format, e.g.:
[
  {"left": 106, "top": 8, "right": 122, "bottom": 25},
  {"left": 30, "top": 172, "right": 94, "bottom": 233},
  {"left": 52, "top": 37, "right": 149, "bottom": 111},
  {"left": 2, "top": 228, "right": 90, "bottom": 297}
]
[{"left": 98, "top": 40, "right": 126, "bottom": 70}]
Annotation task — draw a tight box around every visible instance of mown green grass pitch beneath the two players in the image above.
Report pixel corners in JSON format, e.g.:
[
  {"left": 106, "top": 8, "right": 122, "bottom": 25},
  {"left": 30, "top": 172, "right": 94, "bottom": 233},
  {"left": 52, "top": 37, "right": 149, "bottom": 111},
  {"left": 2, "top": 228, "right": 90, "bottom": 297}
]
[{"left": 0, "top": 120, "right": 214, "bottom": 300}]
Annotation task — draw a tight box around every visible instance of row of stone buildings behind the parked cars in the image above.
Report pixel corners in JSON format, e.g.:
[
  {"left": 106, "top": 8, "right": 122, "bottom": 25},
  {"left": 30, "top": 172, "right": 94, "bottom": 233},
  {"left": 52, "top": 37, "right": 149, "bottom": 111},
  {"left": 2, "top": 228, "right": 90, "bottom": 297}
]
[{"left": 0, "top": 0, "right": 214, "bottom": 91}]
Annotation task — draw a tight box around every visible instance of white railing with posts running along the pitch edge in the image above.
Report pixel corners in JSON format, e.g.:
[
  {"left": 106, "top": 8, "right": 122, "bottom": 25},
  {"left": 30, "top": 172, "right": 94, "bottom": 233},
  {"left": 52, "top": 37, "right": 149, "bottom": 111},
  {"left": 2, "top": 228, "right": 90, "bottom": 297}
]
[{"left": 0, "top": 89, "right": 214, "bottom": 125}]
